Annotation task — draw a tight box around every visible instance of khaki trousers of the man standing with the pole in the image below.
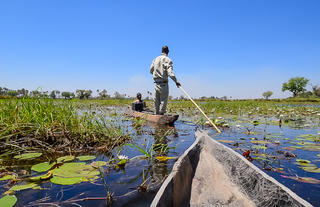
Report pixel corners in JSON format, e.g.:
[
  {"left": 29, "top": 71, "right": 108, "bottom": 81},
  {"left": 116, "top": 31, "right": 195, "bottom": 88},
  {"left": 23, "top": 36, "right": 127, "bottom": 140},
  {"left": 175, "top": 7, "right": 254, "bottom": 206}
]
[{"left": 154, "top": 83, "right": 169, "bottom": 114}]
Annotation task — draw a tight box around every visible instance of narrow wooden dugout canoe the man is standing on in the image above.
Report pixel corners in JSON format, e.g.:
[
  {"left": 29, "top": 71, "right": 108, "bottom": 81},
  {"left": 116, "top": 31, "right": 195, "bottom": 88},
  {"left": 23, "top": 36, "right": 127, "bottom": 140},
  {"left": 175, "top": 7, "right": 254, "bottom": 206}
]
[{"left": 128, "top": 109, "right": 179, "bottom": 125}]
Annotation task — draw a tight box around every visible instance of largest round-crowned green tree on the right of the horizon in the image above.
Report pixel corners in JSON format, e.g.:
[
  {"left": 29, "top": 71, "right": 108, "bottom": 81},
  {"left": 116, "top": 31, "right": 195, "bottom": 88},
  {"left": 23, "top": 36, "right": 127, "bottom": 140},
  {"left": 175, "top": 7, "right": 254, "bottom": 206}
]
[{"left": 282, "top": 77, "right": 309, "bottom": 97}]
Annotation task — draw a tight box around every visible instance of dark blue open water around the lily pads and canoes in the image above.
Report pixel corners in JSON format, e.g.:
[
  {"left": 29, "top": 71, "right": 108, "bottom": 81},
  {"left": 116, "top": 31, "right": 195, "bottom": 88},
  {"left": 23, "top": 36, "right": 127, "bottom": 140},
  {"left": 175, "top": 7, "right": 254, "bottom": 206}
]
[{"left": 0, "top": 109, "right": 320, "bottom": 206}]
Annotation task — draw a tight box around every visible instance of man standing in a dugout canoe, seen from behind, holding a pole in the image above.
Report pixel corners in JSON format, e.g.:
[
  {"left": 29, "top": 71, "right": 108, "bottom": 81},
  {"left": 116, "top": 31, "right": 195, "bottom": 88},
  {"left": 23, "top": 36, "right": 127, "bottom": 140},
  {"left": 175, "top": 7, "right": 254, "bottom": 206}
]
[{"left": 150, "top": 45, "right": 181, "bottom": 115}]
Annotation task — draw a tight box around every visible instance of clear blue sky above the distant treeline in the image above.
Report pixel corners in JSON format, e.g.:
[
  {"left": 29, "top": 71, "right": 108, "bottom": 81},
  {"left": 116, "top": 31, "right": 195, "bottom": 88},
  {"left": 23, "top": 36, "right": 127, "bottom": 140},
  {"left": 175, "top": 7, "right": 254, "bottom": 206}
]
[{"left": 0, "top": 0, "right": 320, "bottom": 98}]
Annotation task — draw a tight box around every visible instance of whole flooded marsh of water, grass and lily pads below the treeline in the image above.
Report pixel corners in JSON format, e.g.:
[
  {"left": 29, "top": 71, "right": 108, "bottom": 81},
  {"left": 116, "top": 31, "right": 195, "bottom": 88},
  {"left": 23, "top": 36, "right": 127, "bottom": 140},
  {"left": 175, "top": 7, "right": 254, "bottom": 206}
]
[{"left": 0, "top": 98, "right": 320, "bottom": 206}]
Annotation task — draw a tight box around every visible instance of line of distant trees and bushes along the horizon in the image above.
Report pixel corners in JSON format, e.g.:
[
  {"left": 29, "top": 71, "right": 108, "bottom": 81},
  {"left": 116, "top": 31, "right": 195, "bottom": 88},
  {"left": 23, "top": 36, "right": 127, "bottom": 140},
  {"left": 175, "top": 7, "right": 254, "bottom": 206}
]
[{"left": 0, "top": 77, "right": 320, "bottom": 101}]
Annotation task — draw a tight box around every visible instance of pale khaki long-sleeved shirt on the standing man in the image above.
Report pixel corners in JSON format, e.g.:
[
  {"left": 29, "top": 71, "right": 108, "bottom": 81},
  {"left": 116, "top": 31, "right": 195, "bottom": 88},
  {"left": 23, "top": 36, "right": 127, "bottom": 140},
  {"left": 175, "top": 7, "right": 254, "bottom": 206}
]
[{"left": 150, "top": 53, "right": 177, "bottom": 82}]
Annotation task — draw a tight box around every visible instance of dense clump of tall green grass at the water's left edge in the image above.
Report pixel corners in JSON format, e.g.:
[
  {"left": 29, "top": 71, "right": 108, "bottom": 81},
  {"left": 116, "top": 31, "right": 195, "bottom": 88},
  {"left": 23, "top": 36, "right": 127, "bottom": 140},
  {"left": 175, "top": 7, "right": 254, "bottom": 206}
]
[{"left": 0, "top": 98, "right": 129, "bottom": 152}]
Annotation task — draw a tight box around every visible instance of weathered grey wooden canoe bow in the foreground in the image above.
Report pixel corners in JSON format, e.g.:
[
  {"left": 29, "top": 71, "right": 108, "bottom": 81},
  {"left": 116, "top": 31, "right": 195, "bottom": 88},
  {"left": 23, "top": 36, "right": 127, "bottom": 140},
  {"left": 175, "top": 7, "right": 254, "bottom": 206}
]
[{"left": 151, "top": 131, "right": 312, "bottom": 207}]
